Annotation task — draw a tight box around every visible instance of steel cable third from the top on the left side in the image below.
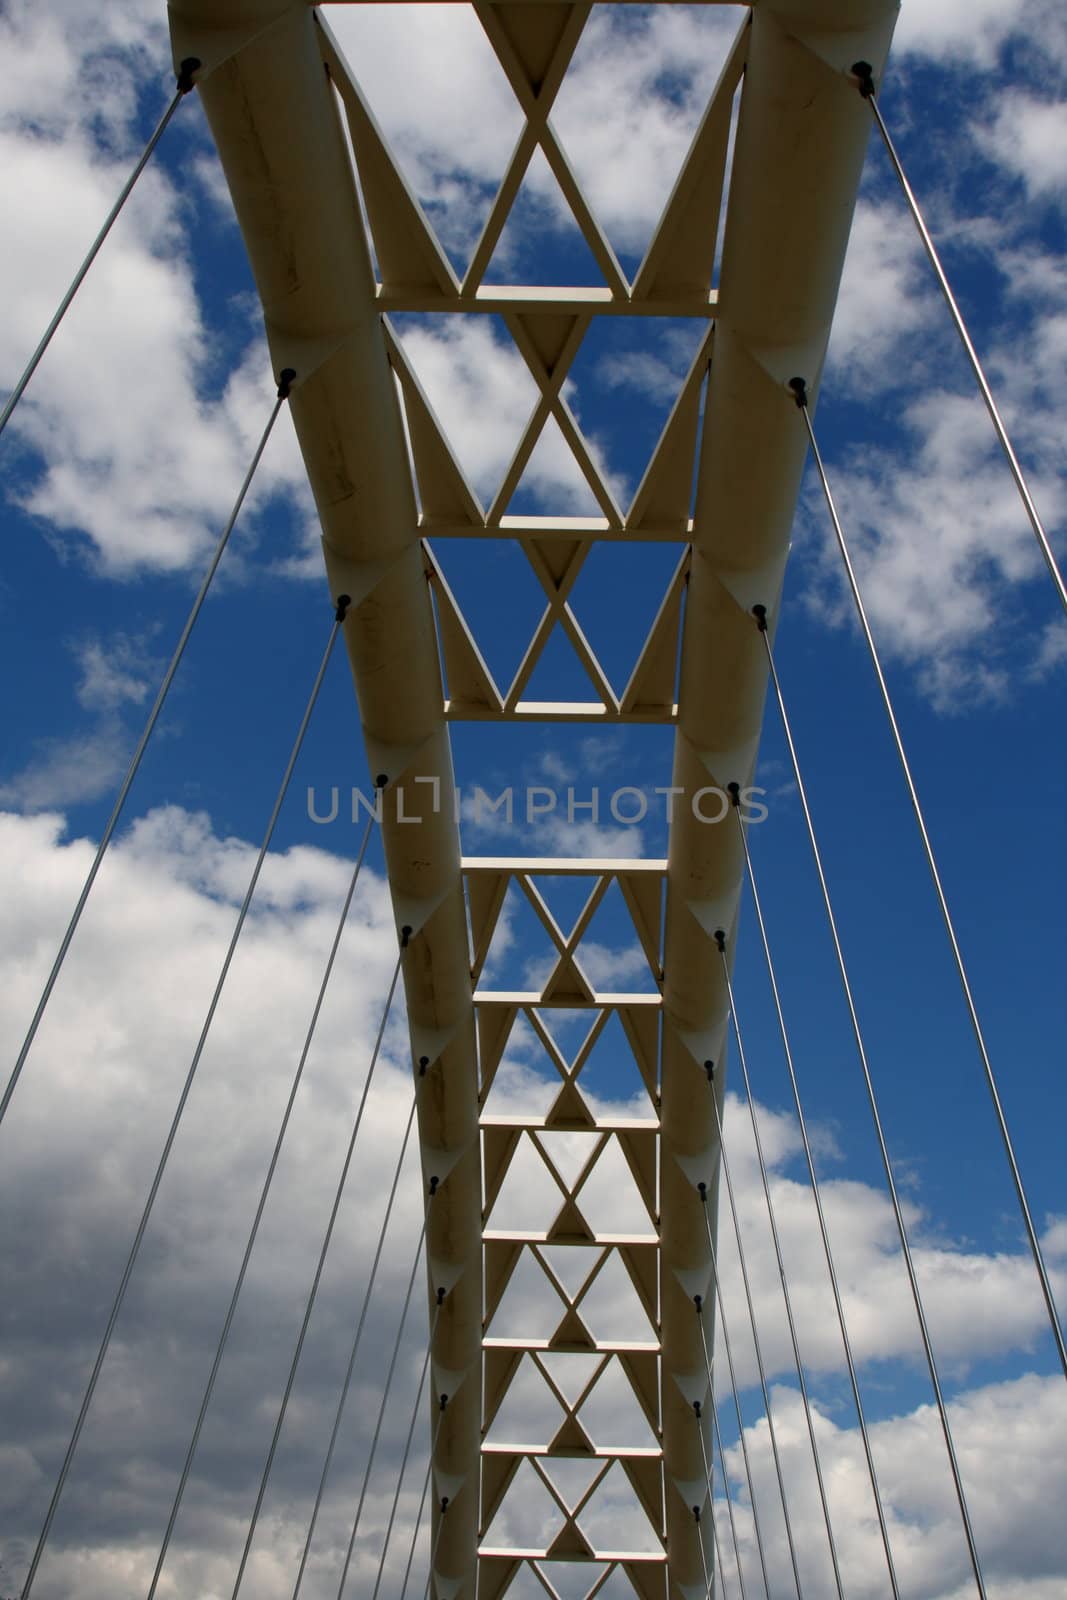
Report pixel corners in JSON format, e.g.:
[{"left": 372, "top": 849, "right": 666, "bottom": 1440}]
[{"left": 22, "top": 595, "right": 350, "bottom": 1600}]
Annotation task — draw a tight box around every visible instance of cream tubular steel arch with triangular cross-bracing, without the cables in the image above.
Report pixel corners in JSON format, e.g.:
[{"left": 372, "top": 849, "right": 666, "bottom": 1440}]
[{"left": 170, "top": 0, "right": 897, "bottom": 1600}]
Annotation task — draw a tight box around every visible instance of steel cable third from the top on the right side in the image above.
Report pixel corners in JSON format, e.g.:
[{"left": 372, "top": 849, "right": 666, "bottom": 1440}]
[{"left": 753, "top": 592, "right": 985, "bottom": 1600}]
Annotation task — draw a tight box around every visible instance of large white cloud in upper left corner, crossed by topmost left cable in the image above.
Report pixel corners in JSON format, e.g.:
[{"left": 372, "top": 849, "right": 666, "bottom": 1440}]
[{"left": 0, "top": 5, "right": 307, "bottom": 573}]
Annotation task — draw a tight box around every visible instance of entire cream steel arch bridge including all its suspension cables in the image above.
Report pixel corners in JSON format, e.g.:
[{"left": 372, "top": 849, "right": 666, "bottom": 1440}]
[{"left": 0, "top": 0, "right": 1067, "bottom": 1600}]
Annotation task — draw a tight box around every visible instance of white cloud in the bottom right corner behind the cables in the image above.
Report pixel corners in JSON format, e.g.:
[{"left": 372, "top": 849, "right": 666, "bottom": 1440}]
[{"left": 720, "top": 1376, "right": 1067, "bottom": 1600}]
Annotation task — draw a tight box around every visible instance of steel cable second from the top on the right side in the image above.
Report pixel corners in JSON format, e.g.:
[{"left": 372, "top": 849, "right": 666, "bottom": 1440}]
[{"left": 790, "top": 378, "right": 1067, "bottom": 1378}]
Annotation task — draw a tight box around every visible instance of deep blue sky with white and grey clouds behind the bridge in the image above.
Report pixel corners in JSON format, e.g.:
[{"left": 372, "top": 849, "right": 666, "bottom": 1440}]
[{"left": 0, "top": 0, "right": 1067, "bottom": 1600}]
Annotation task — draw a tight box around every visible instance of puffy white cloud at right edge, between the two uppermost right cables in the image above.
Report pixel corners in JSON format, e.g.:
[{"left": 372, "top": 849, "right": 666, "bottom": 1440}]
[{"left": 806, "top": 368, "right": 1067, "bottom": 712}]
